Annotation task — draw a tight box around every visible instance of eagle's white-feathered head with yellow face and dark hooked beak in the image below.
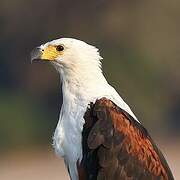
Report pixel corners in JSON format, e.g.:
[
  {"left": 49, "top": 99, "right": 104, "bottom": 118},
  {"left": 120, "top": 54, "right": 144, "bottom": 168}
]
[{"left": 31, "top": 38, "right": 102, "bottom": 76}]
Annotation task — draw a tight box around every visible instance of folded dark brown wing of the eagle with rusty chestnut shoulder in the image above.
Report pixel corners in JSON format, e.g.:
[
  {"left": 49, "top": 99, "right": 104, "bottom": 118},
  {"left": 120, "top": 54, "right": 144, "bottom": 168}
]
[{"left": 77, "top": 98, "right": 174, "bottom": 180}]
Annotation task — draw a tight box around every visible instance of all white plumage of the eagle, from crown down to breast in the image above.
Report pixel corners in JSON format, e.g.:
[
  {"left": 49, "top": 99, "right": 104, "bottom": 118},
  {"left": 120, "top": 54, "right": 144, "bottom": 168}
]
[{"left": 37, "top": 38, "right": 137, "bottom": 180}]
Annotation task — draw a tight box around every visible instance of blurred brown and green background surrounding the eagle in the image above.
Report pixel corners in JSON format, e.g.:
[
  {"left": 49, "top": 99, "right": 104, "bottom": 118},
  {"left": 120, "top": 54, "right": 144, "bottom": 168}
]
[{"left": 0, "top": 0, "right": 180, "bottom": 180}]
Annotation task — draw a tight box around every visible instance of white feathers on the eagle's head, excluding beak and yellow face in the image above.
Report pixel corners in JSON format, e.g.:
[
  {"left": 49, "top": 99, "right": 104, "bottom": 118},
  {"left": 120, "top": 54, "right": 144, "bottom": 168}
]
[{"left": 41, "top": 38, "right": 102, "bottom": 79}]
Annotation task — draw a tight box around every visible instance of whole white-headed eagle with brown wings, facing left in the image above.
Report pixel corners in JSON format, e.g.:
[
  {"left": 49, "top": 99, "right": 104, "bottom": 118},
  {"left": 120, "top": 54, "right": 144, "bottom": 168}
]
[{"left": 31, "top": 37, "right": 174, "bottom": 180}]
